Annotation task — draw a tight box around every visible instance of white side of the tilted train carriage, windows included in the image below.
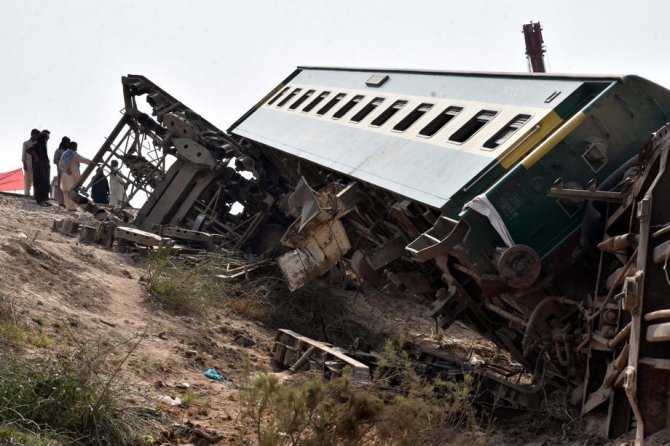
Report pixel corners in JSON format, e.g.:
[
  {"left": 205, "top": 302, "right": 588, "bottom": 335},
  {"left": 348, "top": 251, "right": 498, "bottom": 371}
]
[{"left": 229, "top": 67, "right": 619, "bottom": 208}]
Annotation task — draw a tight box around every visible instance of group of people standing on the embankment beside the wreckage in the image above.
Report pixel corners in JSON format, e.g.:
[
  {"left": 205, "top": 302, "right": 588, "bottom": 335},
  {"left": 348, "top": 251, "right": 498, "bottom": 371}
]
[{"left": 21, "top": 129, "right": 125, "bottom": 211}]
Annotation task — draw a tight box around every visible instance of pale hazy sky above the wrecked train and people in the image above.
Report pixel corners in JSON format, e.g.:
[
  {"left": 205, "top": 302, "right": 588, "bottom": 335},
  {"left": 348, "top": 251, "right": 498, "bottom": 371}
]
[{"left": 0, "top": 0, "right": 670, "bottom": 172}]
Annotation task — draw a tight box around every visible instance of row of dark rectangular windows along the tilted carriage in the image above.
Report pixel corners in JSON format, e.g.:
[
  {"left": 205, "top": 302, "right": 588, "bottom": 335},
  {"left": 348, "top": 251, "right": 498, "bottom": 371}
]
[{"left": 268, "top": 87, "right": 530, "bottom": 150}]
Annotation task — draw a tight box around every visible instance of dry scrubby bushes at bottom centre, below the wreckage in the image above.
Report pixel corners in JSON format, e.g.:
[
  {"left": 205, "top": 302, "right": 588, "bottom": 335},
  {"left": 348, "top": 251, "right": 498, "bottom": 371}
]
[{"left": 241, "top": 339, "right": 485, "bottom": 446}]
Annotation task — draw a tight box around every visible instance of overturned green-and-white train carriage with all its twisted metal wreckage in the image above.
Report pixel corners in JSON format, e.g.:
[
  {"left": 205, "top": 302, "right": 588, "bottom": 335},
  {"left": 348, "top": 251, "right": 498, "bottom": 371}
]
[{"left": 64, "top": 67, "right": 670, "bottom": 443}]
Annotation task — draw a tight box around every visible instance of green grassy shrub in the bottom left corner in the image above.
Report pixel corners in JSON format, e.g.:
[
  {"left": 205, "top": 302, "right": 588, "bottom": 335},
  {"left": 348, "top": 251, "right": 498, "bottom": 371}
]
[{"left": 0, "top": 330, "right": 159, "bottom": 445}]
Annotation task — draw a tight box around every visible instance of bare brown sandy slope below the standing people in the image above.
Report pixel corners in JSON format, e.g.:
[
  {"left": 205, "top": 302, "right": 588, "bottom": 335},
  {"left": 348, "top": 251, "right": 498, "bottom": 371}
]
[{"left": 0, "top": 195, "right": 274, "bottom": 444}]
